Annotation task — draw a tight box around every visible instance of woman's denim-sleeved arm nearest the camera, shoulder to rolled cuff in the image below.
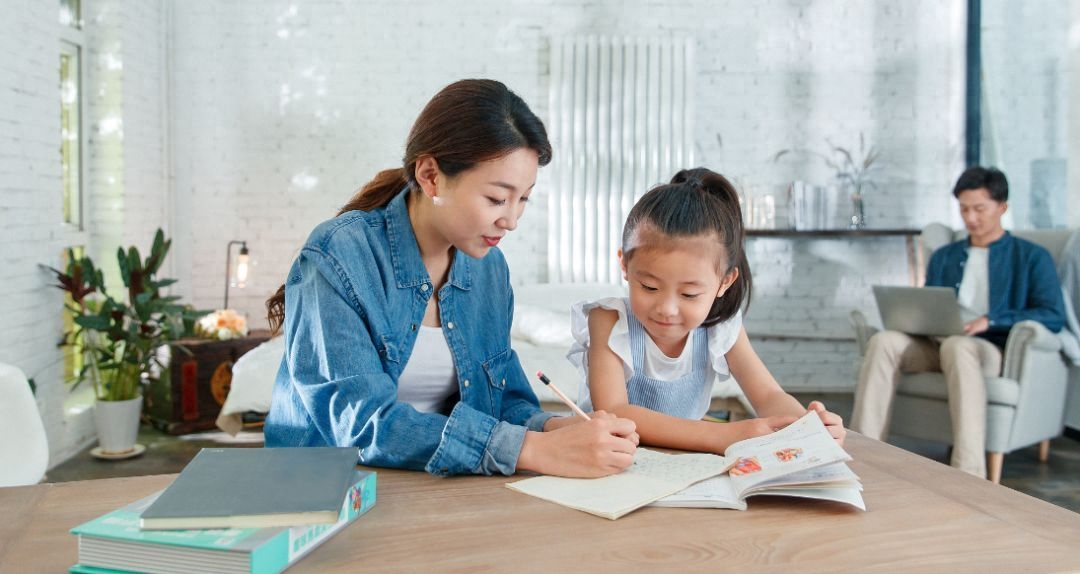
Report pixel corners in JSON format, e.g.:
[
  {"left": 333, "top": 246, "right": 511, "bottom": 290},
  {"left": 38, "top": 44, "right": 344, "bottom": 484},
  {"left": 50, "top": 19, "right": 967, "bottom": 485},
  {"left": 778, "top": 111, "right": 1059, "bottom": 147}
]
[{"left": 274, "top": 250, "right": 544, "bottom": 475}]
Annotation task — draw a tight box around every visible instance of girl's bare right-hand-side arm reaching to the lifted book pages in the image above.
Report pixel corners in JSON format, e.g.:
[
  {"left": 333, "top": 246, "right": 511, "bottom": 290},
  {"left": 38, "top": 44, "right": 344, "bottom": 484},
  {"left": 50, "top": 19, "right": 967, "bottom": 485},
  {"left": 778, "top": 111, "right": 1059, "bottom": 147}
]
[{"left": 725, "top": 328, "right": 847, "bottom": 444}]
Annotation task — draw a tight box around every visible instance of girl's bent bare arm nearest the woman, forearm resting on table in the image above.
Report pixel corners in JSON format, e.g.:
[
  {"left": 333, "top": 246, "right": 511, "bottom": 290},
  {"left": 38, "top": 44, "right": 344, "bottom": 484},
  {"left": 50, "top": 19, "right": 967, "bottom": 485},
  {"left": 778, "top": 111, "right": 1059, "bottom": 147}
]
[{"left": 589, "top": 308, "right": 790, "bottom": 453}]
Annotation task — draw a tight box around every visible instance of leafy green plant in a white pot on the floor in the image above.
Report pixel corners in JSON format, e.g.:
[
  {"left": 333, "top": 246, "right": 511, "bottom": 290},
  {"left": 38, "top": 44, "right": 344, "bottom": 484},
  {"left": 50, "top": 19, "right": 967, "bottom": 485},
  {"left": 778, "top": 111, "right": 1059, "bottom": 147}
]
[{"left": 49, "top": 229, "right": 193, "bottom": 457}]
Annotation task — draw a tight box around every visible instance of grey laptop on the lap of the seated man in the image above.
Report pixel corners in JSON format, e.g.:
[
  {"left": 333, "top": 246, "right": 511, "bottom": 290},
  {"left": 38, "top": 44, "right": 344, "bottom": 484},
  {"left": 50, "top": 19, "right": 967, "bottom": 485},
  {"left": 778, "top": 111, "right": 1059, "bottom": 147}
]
[{"left": 874, "top": 285, "right": 963, "bottom": 337}]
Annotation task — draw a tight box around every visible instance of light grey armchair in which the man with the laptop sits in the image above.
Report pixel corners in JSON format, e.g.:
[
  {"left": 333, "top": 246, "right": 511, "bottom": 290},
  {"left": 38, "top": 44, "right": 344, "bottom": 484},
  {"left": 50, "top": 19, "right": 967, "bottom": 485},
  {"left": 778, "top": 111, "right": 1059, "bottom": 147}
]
[{"left": 851, "top": 224, "right": 1071, "bottom": 482}]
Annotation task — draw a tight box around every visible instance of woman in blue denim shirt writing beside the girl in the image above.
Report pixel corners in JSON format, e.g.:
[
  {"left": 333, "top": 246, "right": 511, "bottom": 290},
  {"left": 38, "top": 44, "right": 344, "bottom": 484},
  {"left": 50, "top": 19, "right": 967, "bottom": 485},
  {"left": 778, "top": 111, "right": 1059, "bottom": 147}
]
[{"left": 265, "top": 80, "right": 637, "bottom": 477}]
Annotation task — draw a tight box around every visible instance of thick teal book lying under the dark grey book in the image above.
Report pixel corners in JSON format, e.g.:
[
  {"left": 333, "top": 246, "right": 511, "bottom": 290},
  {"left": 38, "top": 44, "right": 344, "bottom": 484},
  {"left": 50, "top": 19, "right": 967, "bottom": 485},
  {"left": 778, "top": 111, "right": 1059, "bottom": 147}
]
[{"left": 70, "top": 470, "right": 376, "bottom": 574}]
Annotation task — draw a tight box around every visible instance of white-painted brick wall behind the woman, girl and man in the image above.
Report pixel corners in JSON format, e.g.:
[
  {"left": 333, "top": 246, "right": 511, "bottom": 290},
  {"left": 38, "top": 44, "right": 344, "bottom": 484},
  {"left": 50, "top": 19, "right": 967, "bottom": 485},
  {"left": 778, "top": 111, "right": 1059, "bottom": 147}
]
[{"left": 0, "top": 0, "right": 1075, "bottom": 469}]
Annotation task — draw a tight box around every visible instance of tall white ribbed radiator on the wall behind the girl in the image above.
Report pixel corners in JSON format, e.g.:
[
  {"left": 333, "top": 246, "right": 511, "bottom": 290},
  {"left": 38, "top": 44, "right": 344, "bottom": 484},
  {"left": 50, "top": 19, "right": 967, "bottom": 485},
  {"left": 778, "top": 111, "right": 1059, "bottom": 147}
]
[{"left": 548, "top": 36, "right": 694, "bottom": 283}]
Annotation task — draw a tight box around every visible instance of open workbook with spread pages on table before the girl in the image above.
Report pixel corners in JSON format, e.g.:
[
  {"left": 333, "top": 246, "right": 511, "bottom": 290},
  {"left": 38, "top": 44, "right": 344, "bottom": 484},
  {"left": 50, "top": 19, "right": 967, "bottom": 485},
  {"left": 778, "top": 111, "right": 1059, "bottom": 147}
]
[{"left": 507, "top": 413, "right": 865, "bottom": 520}]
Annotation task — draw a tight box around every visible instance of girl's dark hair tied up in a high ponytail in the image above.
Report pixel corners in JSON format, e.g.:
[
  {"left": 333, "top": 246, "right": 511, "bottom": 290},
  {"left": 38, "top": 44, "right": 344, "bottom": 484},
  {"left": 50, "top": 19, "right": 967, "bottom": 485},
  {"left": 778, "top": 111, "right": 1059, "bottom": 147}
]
[{"left": 622, "top": 168, "right": 753, "bottom": 326}]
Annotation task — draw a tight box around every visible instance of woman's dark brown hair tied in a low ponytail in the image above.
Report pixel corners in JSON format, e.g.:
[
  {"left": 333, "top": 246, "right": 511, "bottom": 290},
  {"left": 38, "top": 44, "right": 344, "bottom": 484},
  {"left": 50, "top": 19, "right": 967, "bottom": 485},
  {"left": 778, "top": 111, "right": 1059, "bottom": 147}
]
[{"left": 267, "top": 80, "right": 551, "bottom": 333}]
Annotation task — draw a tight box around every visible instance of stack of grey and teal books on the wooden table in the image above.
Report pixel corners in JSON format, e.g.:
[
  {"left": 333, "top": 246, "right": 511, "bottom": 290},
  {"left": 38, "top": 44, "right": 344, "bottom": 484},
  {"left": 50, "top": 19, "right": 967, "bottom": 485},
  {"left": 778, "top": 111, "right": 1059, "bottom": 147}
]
[{"left": 70, "top": 448, "right": 376, "bottom": 574}]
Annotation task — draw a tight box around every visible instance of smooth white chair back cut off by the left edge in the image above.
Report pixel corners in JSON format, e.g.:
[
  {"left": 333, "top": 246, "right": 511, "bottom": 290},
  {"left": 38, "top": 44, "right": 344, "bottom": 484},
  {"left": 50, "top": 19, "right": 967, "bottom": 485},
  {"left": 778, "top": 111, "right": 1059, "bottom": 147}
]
[{"left": 0, "top": 363, "right": 49, "bottom": 486}]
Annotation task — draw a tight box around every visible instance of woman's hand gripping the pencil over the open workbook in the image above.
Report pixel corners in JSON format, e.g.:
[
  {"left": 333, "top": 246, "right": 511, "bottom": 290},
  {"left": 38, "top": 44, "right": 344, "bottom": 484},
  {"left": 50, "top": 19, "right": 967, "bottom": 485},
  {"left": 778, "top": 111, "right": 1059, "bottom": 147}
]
[{"left": 517, "top": 411, "right": 638, "bottom": 478}]
